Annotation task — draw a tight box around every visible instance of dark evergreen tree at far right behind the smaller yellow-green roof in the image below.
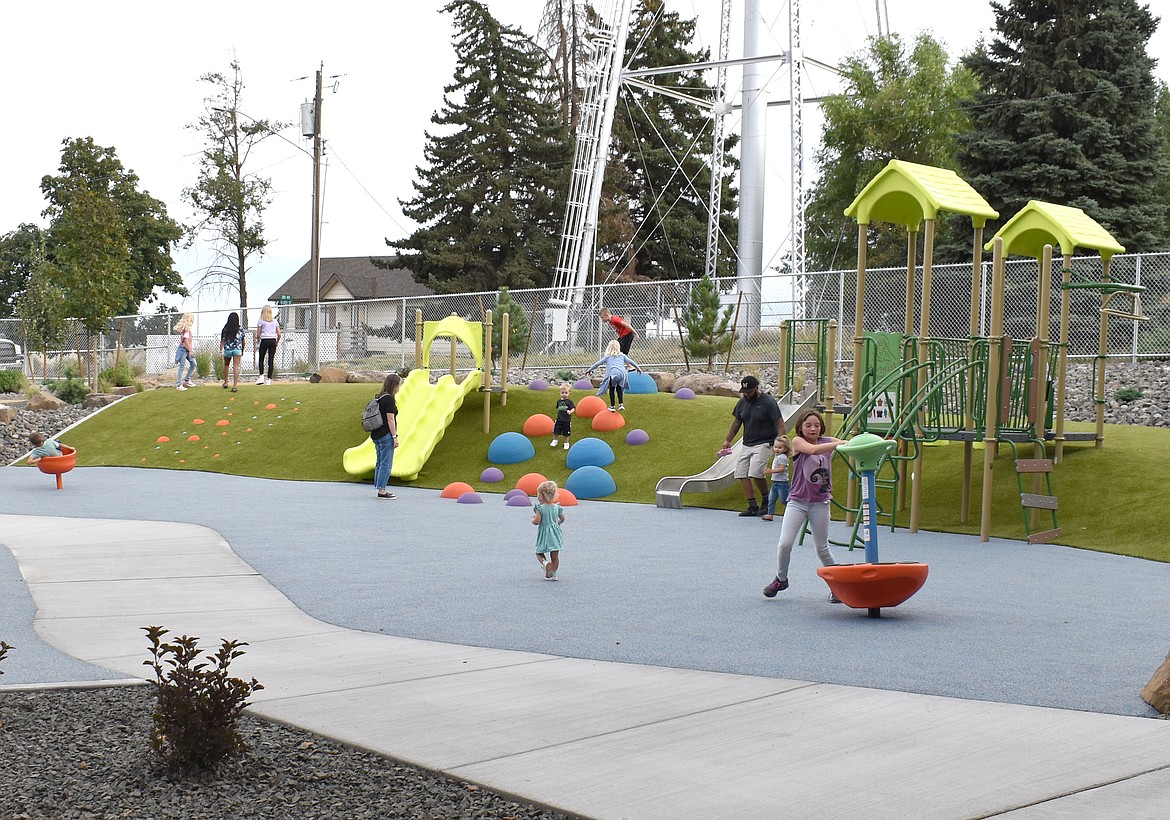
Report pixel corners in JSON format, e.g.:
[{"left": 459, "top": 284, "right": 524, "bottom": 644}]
[{"left": 958, "top": 0, "right": 1170, "bottom": 251}]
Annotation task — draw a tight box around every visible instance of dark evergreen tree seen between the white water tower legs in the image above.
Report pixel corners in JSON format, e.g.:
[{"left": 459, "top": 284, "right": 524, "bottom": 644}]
[{"left": 598, "top": 0, "right": 738, "bottom": 280}]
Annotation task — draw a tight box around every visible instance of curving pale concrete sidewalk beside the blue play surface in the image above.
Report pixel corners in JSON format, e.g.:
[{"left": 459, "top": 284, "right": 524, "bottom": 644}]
[{"left": 0, "top": 505, "right": 1170, "bottom": 820}]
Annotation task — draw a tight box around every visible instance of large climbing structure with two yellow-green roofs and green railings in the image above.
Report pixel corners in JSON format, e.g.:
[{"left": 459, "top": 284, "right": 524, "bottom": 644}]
[{"left": 779, "top": 160, "right": 1142, "bottom": 546}]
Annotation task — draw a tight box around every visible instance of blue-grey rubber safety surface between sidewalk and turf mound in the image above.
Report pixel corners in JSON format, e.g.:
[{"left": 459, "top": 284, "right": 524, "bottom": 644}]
[{"left": 0, "top": 467, "right": 1170, "bottom": 716}]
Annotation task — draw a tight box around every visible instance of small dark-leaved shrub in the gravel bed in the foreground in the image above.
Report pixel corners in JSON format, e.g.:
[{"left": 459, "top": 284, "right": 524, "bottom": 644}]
[{"left": 143, "top": 626, "right": 263, "bottom": 774}]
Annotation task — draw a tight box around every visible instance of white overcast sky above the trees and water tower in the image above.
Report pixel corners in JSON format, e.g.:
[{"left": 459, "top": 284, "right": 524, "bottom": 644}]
[{"left": 0, "top": 0, "right": 1170, "bottom": 310}]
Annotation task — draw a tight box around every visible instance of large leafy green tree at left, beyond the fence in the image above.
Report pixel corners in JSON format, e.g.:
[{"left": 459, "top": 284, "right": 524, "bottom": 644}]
[{"left": 41, "top": 137, "right": 187, "bottom": 316}]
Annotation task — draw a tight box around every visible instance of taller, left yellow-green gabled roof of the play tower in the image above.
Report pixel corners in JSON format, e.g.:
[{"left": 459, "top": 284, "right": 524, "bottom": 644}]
[{"left": 845, "top": 159, "right": 999, "bottom": 230}]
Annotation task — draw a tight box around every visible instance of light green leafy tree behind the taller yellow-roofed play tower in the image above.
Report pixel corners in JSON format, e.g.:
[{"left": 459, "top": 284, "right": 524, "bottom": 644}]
[{"left": 805, "top": 34, "right": 975, "bottom": 270}]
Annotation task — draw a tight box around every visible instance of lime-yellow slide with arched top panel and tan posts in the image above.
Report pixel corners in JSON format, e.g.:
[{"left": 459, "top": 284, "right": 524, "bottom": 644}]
[{"left": 342, "top": 311, "right": 508, "bottom": 481}]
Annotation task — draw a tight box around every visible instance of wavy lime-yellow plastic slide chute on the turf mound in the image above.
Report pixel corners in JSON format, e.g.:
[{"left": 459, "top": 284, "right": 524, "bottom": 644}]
[{"left": 342, "top": 368, "right": 483, "bottom": 481}]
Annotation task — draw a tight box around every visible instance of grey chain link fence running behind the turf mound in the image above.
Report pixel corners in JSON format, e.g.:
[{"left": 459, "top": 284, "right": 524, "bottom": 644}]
[{"left": 0, "top": 254, "right": 1170, "bottom": 380}]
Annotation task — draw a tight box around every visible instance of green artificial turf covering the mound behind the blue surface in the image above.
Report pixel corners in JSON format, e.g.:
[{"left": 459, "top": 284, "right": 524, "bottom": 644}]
[{"left": 57, "top": 383, "right": 1170, "bottom": 561}]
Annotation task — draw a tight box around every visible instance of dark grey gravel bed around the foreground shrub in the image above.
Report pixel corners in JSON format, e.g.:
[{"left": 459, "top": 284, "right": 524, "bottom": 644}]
[{"left": 0, "top": 685, "right": 566, "bottom": 820}]
